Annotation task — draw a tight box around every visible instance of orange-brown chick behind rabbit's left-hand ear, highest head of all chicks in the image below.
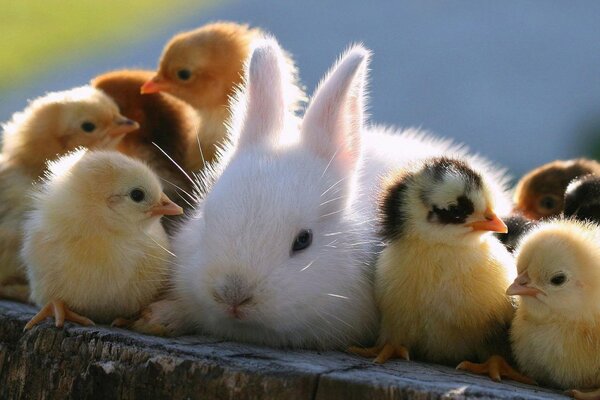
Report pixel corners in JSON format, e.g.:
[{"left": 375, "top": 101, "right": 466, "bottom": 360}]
[{"left": 141, "top": 22, "right": 303, "bottom": 169}]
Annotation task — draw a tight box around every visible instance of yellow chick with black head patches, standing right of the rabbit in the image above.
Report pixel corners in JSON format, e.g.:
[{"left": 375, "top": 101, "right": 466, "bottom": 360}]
[{"left": 351, "top": 158, "right": 526, "bottom": 381}]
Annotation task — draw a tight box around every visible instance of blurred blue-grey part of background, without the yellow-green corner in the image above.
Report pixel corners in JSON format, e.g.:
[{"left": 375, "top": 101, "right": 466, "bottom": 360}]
[{"left": 0, "top": 0, "right": 600, "bottom": 175}]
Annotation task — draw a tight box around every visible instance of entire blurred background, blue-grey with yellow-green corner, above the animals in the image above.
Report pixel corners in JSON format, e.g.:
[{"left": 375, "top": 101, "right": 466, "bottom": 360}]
[{"left": 0, "top": 0, "right": 600, "bottom": 177}]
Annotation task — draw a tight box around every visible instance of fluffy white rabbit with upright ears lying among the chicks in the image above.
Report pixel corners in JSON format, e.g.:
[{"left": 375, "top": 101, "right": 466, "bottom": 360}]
[{"left": 154, "top": 39, "right": 510, "bottom": 349}]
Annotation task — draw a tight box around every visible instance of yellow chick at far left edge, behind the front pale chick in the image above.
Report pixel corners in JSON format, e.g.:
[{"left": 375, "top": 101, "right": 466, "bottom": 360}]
[{"left": 0, "top": 86, "right": 138, "bottom": 301}]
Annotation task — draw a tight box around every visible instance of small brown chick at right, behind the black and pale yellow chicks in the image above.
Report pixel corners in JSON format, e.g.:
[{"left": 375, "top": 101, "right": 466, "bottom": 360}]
[{"left": 514, "top": 158, "right": 600, "bottom": 219}]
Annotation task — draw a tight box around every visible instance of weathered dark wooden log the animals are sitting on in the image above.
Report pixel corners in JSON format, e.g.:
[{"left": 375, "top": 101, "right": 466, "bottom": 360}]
[{"left": 0, "top": 301, "right": 564, "bottom": 400}]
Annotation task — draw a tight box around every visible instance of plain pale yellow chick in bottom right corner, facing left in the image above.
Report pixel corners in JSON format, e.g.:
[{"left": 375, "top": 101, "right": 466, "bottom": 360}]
[{"left": 507, "top": 220, "right": 600, "bottom": 398}]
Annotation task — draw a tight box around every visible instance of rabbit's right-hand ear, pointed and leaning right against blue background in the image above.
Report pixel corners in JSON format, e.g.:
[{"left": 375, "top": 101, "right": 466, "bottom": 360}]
[{"left": 302, "top": 45, "right": 370, "bottom": 172}]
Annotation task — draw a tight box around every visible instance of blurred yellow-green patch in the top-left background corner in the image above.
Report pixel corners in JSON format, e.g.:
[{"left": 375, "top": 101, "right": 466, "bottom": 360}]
[{"left": 0, "top": 0, "right": 210, "bottom": 91}]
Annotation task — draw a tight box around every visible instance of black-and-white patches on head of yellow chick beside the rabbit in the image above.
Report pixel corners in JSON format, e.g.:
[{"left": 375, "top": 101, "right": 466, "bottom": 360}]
[{"left": 380, "top": 157, "right": 483, "bottom": 240}]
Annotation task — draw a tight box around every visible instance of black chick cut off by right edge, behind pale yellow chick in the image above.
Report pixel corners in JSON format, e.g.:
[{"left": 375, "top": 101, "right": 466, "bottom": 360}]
[{"left": 564, "top": 175, "right": 600, "bottom": 223}]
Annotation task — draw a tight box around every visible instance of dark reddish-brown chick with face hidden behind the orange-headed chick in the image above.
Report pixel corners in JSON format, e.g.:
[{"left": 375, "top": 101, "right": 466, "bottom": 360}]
[{"left": 91, "top": 70, "right": 199, "bottom": 216}]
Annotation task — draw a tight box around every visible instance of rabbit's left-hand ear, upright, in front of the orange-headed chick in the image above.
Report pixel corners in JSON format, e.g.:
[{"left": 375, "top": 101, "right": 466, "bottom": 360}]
[{"left": 239, "top": 38, "right": 293, "bottom": 146}]
